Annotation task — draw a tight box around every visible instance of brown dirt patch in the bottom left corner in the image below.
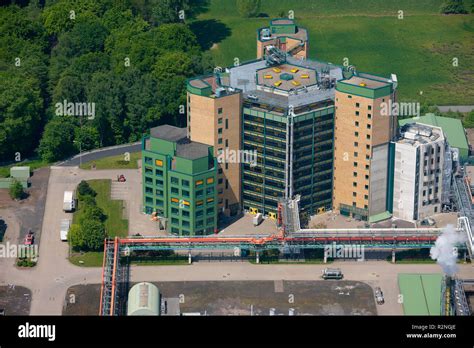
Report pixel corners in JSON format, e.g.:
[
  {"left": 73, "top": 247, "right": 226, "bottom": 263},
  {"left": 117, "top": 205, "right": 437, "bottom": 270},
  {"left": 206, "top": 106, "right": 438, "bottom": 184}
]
[{"left": 0, "top": 286, "right": 31, "bottom": 315}]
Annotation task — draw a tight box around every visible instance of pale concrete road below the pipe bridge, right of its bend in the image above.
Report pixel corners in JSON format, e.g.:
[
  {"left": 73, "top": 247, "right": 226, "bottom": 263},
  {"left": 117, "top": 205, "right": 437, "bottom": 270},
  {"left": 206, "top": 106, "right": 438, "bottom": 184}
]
[{"left": 130, "top": 261, "right": 474, "bottom": 315}]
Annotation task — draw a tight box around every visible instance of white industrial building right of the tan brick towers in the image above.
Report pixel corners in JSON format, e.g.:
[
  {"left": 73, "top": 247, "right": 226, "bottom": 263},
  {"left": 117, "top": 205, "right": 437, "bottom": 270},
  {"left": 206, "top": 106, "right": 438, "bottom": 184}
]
[{"left": 393, "top": 123, "right": 452, "bottom": 221}]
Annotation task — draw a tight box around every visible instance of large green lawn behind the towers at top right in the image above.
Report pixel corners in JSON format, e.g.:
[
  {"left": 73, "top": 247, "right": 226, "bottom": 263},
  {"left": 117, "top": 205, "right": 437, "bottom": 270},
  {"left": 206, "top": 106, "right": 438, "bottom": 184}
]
[{"left": 192, "top": 0, "right": 474, "bottom": 105}]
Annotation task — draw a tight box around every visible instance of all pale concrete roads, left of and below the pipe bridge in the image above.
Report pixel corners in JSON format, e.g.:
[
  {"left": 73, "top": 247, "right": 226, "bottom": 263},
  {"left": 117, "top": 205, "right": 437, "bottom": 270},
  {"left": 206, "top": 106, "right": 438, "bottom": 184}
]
[{"left": 0, "top": 167, "right": 474, "bottom": 315}]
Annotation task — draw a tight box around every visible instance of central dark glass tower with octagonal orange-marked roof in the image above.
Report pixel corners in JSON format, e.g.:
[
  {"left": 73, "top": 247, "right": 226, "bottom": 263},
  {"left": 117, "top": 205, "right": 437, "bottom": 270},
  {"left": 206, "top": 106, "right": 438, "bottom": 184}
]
[{"left": 228, "top": 54, "right": 342, "bottom": 217}]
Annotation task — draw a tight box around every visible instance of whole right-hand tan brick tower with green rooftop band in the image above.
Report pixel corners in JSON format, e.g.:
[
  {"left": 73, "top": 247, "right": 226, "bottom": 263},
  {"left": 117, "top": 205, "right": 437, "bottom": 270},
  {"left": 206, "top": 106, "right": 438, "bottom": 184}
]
[{"left": 333, "top": 73, "right": 397, "bottom": 222}]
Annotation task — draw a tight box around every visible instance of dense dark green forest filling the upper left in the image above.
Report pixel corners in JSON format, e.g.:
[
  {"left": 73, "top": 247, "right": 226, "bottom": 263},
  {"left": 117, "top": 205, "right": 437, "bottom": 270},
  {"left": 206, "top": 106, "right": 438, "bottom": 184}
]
[{"left": 0, "top": 0, "right": 212, "bottom": 163}]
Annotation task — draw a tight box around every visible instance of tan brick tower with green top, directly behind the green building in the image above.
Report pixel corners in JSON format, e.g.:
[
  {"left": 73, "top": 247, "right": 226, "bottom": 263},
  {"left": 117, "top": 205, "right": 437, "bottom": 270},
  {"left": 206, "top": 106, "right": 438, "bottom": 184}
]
[{"left": 187, "top": 77, "right": 242, "bottom": 216}]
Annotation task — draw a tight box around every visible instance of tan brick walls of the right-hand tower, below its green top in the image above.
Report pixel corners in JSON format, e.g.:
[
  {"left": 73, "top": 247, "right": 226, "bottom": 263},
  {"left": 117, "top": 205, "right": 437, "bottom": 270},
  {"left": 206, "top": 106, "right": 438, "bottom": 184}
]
[{"left": 333, "top": 91, "right": 396, "bottom": 212}]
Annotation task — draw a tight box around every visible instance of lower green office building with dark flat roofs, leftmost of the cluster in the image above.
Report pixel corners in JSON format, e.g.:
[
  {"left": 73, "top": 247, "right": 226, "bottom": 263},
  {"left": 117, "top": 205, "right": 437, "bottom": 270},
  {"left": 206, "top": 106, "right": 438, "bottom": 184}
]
[{"left": 142, "top": 125, "right": 217, "bottom": 236}]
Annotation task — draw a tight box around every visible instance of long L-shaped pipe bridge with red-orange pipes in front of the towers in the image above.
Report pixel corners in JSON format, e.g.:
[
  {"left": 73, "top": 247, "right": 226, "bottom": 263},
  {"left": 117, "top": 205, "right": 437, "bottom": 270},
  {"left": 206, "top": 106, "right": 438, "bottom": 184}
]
[{"left": 99, "top": 228, "right": 464, "bottom": 315}]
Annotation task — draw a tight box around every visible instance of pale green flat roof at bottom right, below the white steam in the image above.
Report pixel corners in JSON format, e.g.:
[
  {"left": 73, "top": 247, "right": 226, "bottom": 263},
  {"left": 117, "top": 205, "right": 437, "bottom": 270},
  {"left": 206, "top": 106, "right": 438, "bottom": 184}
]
[{"left": 398, "top": 273, "right": 443, "bottom": 315}]
